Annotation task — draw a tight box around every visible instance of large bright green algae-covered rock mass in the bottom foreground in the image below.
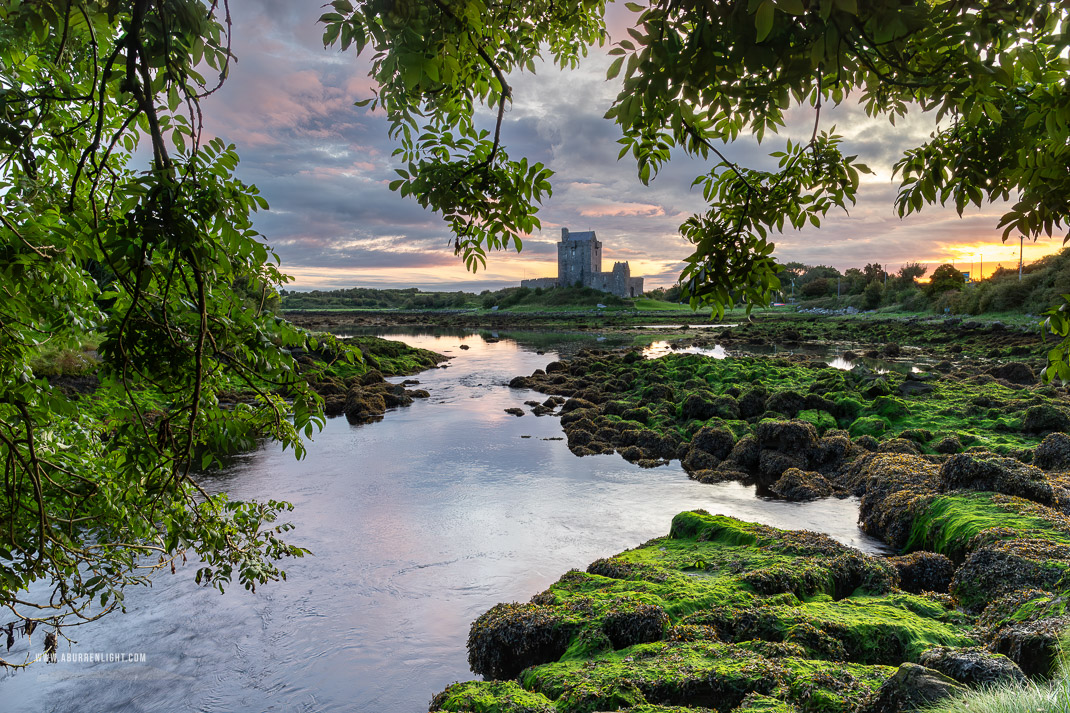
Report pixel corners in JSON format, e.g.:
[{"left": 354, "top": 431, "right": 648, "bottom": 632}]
[{"left": 435, "top": 511, "right": 976, "bottom": 713}]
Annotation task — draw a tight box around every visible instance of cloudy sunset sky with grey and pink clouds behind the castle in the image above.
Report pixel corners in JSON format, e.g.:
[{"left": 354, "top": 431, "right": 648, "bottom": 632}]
[{"left": 203, "top": 0, "right": 1060, "bottom": 290}]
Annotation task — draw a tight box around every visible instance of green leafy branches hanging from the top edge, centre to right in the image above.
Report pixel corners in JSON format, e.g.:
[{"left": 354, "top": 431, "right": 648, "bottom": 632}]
[{"left": 321, "top": 0, "right": 1070, "bottom": 372}]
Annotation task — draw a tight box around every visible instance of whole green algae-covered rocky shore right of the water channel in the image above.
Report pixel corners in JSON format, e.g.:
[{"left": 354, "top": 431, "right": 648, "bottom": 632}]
[{"left": 431, "top": 327, "right": 1070, "bottom": 713}]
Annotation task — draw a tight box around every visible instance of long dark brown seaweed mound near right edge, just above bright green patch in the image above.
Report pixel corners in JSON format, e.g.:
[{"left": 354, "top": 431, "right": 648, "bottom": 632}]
[{"left": 938, "top": 453, "right": 1054, "bottom": 505}]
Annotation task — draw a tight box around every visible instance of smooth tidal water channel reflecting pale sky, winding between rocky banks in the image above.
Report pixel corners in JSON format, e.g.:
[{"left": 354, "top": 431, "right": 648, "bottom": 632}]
[{"left": 0, "top": 333, "right": 880, "bottom": 713}]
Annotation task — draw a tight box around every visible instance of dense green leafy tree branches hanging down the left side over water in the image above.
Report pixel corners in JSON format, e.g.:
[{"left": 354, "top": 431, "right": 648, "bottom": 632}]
[{"left": 0, "top": 0, "right": 333, "bottom": 665}]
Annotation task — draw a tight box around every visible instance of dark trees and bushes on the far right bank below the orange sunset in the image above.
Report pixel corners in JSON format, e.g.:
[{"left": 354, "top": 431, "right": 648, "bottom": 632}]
[{"left": 780, "top": 248, "right": 1070, "bottom": 315}]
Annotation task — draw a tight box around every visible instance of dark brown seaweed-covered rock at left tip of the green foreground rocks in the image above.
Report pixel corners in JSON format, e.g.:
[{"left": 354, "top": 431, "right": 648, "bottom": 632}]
[{"left": 468, "top": 604, "right": 577, "bottom": 679}]
